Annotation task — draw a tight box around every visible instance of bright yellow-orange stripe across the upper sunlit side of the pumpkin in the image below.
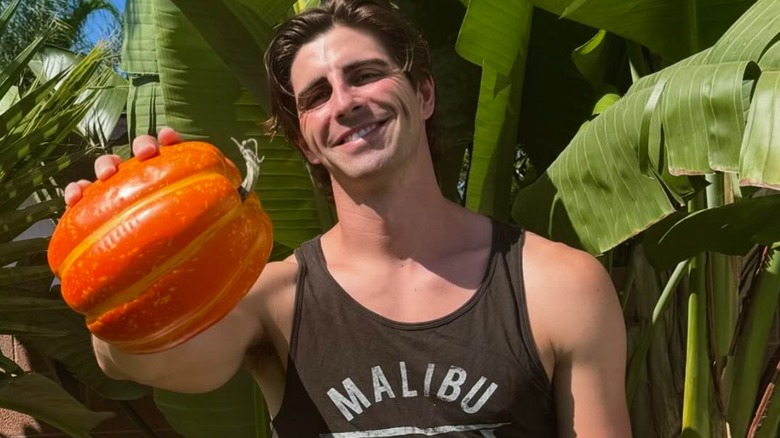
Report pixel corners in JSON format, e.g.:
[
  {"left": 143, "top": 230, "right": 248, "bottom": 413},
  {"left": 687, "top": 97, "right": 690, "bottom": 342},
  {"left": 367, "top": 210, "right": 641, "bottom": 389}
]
[{"left": 56, "top": 170, "right": 233, "bottom": 278}]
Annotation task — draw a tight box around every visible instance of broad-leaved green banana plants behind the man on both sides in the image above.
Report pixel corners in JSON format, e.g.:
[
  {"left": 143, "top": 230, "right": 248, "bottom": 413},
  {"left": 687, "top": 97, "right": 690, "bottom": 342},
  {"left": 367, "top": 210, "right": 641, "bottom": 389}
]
[{"left": 38, "top": 0, "right": 780, "bottom": 437}]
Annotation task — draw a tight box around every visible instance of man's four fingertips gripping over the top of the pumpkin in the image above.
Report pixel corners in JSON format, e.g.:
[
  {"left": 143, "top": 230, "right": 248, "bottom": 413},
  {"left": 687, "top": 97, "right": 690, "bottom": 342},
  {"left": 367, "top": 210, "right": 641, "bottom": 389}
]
[{"left": 65, "top": 128, "right": 182, "bottom": 207}]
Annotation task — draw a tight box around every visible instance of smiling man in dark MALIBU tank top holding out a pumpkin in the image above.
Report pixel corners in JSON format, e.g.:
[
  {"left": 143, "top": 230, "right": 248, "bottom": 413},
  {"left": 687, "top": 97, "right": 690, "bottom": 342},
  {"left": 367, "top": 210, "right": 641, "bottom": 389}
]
[{"left": 66, "top": 0, "right": 631, "bottom": 437}]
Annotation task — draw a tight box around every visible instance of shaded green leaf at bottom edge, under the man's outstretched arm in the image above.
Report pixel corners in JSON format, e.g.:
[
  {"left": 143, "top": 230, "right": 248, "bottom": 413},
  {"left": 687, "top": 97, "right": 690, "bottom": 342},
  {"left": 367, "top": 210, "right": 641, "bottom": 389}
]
[{"left": 154, "top": 371, "right": 270, "bottom": 438}]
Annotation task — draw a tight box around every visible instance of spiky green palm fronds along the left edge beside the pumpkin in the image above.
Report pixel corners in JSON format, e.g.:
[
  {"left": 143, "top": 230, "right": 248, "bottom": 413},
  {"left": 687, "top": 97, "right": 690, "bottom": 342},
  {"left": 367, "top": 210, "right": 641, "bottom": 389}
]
[{"left": 0, "top": 0, "right": 147, "bottom": 437}]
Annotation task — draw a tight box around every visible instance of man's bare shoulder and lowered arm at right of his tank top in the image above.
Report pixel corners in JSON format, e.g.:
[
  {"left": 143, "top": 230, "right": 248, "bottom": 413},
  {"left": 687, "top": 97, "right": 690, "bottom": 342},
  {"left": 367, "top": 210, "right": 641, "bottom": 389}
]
[{"left": 529, "top": 236, "right": 631, "bottom": 438}]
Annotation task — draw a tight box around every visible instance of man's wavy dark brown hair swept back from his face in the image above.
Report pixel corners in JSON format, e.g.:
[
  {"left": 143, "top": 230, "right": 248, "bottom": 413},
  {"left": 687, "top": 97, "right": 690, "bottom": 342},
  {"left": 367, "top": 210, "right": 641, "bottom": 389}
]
[{"left": 265, "top": 0, "right": 441, "bottom": 198}]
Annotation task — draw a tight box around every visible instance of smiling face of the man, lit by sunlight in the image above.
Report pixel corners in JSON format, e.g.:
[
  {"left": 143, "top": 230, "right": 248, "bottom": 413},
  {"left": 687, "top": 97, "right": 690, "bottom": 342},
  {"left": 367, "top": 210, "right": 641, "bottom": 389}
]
[{"left": 290, "top": 26, "right": 434, "bottom": 189}]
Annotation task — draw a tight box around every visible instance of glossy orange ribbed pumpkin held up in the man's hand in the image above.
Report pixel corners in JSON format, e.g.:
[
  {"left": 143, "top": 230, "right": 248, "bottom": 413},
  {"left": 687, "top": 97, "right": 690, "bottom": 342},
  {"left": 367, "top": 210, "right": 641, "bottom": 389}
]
[{"left": 48, "top": 142, "right": 273, "bottom": 353}]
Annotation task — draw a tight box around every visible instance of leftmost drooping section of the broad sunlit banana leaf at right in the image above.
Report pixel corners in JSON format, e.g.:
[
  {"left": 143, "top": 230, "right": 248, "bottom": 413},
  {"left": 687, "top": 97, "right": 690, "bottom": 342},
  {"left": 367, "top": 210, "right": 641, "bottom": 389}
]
[{"left": 512, "top": 84, "right": 674, "bottom": 254}]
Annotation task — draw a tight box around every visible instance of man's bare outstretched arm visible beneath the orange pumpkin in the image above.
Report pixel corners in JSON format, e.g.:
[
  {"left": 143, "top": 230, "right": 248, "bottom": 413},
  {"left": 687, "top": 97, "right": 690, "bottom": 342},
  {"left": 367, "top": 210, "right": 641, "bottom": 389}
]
[{"left": 93, "top": 258, "right": 298, "bottom": 393}]
